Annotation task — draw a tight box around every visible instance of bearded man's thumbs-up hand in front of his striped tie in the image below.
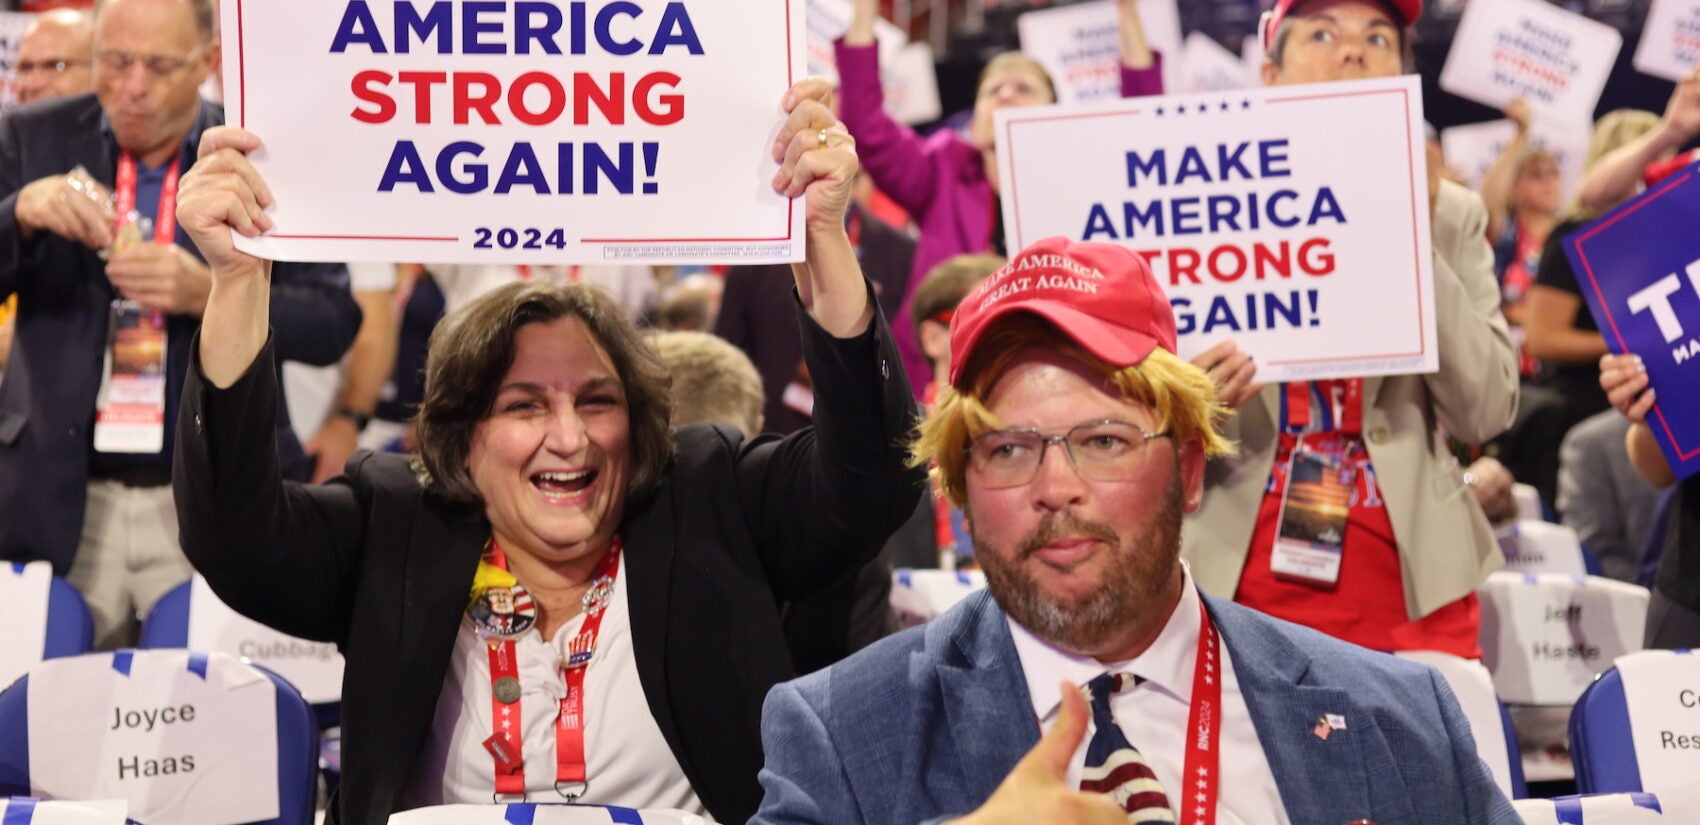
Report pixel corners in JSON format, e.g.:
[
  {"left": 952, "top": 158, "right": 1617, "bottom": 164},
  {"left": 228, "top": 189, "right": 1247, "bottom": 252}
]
[{"left": 955, "top": 682, "right": 1127, "bottom": 825}]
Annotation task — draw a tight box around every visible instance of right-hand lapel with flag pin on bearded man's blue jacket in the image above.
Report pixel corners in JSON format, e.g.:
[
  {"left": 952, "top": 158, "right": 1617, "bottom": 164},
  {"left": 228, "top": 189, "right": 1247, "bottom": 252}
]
[{"left": 1205, "top": 599, "right": 1375, "bottom": 825}]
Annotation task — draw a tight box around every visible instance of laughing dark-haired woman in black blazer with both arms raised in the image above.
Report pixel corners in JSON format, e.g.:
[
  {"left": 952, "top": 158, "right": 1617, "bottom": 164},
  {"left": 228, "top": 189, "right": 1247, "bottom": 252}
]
[{"left": 175, "top": 88, "right": 921, "bottom": 825}]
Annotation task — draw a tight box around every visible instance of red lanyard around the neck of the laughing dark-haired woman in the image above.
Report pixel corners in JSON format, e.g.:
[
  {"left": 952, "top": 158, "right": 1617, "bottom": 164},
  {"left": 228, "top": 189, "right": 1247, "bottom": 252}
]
[{"left": 485, "top": 538, "right": 621, "bottom": 801}]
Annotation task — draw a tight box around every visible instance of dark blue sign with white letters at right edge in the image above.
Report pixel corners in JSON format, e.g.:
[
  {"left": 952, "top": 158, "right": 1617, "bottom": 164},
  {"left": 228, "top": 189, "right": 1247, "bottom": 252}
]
[{"left": 1564, "top": 167, "right": 1700, "bottom": 478}]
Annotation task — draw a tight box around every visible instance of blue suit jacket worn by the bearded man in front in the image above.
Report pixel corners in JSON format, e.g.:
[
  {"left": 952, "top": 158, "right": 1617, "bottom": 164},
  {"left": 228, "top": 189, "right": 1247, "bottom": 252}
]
[{"left": 751, "top": 592, "right": 1522, "bottom": 825}]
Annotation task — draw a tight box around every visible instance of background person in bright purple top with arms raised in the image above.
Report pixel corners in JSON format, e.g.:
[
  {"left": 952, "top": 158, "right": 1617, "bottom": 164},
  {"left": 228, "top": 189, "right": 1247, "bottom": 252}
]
[{"left": 835, "top": 0, "right": 1163, "bottom": 392}]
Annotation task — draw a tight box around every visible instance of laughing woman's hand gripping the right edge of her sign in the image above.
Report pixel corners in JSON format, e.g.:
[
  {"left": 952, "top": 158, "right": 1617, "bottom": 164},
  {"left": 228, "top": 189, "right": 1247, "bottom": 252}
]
[{"left": 772, "top": 78, "right": 862, "bottom": 228}]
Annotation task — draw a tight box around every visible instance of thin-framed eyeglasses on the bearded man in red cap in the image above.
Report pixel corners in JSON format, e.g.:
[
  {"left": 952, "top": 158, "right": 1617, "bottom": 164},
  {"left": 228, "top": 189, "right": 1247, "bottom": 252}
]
[{"left": 966, "top": 418, "right": 1168, "bottom": 490}]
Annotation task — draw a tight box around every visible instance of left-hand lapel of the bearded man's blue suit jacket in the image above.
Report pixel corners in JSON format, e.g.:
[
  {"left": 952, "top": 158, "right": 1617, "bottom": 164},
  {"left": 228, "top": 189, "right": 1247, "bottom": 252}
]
[{"left": 915, "top": 590, "right": 1039, "bottom": 813}]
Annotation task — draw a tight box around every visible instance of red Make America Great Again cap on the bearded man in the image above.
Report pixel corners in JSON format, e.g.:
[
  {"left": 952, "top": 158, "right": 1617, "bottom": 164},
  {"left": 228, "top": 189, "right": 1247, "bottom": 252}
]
[{"left": 950, "top": 236, "right": 1175, "bottom": 390}]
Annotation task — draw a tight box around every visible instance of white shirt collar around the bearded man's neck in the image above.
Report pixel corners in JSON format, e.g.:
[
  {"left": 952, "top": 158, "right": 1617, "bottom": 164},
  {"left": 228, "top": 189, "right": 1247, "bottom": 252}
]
[{"left": 1005, "top": 561, "right": 1200, "bottom": 720}]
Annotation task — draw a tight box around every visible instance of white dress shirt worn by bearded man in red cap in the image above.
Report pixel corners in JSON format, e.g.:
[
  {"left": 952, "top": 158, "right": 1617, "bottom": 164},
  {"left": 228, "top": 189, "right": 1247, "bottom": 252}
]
[{"left": 1008, "top": 570, "right": 1289, "bottom": 825}]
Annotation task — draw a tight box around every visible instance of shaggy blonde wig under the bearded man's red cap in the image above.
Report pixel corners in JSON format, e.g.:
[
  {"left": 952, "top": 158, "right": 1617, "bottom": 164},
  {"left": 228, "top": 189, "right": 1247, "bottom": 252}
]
[{"left": 910, "top": 313, "right": 1238, "bottom": 507}]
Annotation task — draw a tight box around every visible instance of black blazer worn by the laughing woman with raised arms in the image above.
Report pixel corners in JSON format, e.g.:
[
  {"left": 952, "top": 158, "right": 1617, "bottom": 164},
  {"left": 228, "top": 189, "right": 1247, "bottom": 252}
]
[{"left": 175, "top": 299, "right": 921, "bottom": 825}]
